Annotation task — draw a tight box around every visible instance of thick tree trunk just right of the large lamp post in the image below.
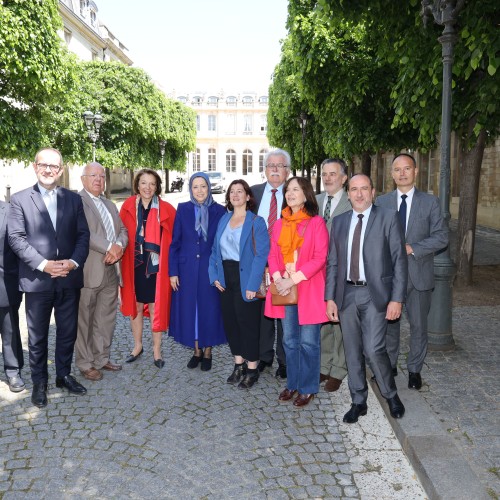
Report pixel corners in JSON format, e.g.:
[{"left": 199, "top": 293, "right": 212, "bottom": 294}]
[{"left": 457, "top": 124, "right": 486, "bottom": 286}]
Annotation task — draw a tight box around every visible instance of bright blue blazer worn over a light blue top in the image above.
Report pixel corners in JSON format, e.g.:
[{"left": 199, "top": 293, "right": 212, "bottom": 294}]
[{"left": 208, "top": 211, "right": 270, "bottom": 302}]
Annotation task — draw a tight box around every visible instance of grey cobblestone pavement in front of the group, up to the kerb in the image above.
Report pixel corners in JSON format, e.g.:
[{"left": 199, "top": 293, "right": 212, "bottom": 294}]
[{"left": 0, "top": 306, "right": 425, "bottom": 499}]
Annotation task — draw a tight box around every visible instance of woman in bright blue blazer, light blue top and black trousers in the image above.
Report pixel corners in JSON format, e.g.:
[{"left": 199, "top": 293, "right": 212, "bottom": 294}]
[{"left": 209, "top": 179, "right": 269, "bottom": 389}]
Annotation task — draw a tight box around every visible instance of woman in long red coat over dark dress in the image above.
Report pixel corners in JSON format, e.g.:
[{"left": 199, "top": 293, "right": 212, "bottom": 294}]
[{"left": 120, "top": 169, "right": 175, "bottom": 368}]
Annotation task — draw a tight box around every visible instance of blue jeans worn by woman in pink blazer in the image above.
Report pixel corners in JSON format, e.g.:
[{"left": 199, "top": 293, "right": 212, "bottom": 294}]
[{"left": 281, "top": 306, "right": 321, "bottom": 394}]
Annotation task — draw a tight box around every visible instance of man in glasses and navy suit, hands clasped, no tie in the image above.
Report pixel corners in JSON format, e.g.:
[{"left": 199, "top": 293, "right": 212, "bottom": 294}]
[{"left": 8, "top": 148, "right": 89, "bottom": 408}]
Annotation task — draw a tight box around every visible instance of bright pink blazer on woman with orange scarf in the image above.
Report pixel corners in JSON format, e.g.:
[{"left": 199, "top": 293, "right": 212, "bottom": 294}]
[{"left": 265, "top": 215, "right": 329, "bottom": 325}]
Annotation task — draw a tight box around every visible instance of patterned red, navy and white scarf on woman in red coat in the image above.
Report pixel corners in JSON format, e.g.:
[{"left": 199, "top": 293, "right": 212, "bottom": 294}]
[{"left": 134, "top": 195, "right": 161, "bottom": 277}]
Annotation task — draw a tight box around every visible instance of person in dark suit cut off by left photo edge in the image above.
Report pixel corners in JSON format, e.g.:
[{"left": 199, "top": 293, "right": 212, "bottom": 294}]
[{"left": 0, "top": 201, "right": 25, "bottom": 392}]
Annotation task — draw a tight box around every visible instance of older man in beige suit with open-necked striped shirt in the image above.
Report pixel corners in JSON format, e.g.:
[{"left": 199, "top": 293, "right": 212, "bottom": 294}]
[{"left": 75, "top": 162, "right": 128, "bottom": 381}]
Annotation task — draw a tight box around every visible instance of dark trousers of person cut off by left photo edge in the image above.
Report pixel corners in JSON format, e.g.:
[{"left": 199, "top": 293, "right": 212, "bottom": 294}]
[{"left": 0, "top": 304, "right": 24, "bottom": 377}]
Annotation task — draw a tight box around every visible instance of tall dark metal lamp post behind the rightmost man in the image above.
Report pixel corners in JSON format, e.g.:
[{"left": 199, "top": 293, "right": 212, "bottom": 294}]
[{"left": 422, "top": 0, "right": 465, "bottom": 350}]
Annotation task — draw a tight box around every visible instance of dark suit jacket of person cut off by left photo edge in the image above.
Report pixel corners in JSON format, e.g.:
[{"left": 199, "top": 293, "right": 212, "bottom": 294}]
[{"left": 0, "top": 201, "right": 22, "bottom": 307}]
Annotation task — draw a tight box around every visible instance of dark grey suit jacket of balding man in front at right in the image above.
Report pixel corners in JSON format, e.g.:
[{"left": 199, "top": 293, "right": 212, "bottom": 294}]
[{"left": 325, "top": 206, "right": 408, "bottom": 311}]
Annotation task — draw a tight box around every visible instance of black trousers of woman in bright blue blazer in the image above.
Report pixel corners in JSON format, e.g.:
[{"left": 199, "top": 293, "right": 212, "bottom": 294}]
[{"left": 221, "top": 260, "right": 261, "bottom": 361}]
